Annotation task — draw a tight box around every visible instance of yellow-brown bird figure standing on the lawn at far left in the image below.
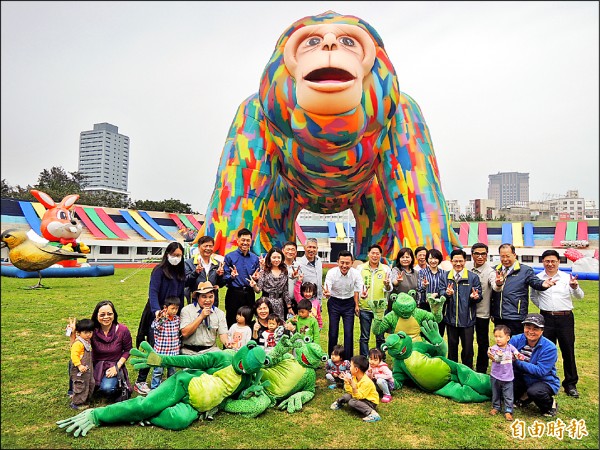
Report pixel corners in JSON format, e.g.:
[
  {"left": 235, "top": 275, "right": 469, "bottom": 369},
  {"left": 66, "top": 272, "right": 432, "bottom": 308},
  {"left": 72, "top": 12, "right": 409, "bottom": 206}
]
[{"left": 0, "top": 230, "right": 86, "bottom": 289}]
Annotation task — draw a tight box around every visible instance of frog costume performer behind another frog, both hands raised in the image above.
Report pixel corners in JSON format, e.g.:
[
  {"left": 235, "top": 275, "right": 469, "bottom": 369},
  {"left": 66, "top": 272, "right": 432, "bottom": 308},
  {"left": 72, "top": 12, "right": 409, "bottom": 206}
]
[{"left": 369, "top": 290, "right": 446, "bottom": 342}]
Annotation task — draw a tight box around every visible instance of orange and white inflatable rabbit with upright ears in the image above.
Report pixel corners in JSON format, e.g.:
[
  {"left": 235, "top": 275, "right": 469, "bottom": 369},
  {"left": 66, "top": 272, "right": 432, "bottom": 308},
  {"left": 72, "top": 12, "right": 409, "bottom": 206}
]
[{"left": 29, "top": 189, "right": 90, "bottom": 267}]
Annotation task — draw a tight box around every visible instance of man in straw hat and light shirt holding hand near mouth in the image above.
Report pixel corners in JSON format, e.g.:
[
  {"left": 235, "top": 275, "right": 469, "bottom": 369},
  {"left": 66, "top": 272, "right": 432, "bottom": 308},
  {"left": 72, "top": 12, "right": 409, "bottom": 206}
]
[{"left": 180, "top": 281, "right": 229, "bottom": 355}]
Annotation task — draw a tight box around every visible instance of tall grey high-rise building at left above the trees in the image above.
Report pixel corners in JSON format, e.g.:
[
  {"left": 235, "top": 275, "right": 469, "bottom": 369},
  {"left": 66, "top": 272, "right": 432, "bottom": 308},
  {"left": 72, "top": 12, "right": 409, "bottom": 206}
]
[{"left": 78, "top": 122, "right": 129, "bottom": 195}]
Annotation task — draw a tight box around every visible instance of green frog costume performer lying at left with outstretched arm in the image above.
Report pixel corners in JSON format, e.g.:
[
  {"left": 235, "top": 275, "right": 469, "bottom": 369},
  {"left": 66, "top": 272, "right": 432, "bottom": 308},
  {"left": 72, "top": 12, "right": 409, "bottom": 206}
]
[{"left": 56, "top": 341, "right": 270, "bottom": 437}]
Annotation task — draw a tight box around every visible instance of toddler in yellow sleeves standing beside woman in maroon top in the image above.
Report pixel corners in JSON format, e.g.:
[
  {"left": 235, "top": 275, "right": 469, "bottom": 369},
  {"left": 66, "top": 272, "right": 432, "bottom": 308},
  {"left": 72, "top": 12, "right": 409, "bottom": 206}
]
[{"left": 69, "top": 319, "right": 96, "bottom": 409}]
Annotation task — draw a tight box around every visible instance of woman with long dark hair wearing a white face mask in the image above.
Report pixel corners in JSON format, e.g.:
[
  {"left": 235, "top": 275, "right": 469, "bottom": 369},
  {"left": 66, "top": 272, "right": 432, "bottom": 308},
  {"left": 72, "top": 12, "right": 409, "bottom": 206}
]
[{"left": 134, "top": 242, "right": 185, "bottom": 395}]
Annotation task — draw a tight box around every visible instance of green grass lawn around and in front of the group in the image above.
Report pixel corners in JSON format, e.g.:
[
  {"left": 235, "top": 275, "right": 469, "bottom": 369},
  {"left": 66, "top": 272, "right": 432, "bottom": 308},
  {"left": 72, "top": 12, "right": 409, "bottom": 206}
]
[{"left": 1, "top": 269, "right": 598, "bottom": 448}]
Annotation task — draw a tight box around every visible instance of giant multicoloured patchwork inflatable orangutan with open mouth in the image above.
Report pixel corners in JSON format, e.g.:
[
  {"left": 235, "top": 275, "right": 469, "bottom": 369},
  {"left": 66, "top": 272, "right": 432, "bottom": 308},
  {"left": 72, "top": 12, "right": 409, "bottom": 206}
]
[{"left": 203, "top": 11, "right": 460, "bottom": 257}]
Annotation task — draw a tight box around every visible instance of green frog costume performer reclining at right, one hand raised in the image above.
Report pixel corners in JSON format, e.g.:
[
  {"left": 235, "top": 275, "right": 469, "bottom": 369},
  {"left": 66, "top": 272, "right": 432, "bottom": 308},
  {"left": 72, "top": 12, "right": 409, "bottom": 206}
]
[{"left": 381, "top": 320, "right": 492, "bottom": 403}]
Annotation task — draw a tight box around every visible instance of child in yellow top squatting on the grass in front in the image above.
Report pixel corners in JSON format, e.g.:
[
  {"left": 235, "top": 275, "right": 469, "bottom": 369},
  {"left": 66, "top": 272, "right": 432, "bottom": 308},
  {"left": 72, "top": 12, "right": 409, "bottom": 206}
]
[{"left": 331, "top": 355, "right": 381, "bottom": 422}]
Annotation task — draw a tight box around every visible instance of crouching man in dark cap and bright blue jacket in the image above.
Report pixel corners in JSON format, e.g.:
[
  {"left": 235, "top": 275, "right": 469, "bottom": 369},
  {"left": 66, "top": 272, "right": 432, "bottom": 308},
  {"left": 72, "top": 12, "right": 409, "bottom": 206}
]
[{"left": 510, "top": 314, "right": 560, "bottom": 417}]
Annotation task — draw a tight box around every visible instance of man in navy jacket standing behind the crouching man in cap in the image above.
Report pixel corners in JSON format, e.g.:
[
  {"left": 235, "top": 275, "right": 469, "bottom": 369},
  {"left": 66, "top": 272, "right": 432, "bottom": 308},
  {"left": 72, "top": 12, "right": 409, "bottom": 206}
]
[{"left": 490, "top": 244, "right": 554, "bottom": 336}]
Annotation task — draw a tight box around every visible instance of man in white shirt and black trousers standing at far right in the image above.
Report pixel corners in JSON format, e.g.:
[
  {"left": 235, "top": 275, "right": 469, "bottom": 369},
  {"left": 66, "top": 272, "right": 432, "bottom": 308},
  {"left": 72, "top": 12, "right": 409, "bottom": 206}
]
[{"left": 531, "top": 250, "right": 584, "bottom": 398}]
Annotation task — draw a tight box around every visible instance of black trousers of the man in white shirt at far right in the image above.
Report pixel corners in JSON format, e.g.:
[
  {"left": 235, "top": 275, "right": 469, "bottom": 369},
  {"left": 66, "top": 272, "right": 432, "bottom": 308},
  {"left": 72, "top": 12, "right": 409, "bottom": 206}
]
[{"left": 542, "top": 311, "right": 579, "bottom": 389}]
